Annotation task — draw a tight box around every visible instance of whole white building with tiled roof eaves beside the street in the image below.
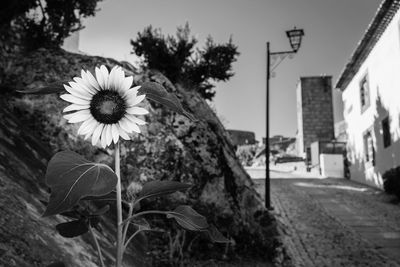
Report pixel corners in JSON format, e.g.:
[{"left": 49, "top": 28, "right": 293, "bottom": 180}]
[{"left": 336, "top": 0, "right": 400, "bottom": 188}]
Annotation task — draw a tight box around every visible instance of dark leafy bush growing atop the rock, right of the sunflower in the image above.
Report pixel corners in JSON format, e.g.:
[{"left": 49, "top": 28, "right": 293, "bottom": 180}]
[{"left": 131, "top": 23, "right": 239, "bottom": 100}]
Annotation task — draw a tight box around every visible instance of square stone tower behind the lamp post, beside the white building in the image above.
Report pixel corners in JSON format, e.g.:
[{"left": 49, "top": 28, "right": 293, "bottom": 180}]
[{"left": 296, "top": 75, "right": 335, "bottom": 158}]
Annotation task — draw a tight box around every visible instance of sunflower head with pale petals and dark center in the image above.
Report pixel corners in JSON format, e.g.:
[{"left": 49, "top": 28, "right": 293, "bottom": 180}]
[{"left": 60, "top": 65, "right": 149, "bottom": 148}]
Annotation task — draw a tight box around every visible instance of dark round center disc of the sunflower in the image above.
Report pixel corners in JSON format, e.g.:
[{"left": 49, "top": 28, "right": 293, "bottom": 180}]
[{"left": 90, "top": 90, "right": 126, "bottom": 124}]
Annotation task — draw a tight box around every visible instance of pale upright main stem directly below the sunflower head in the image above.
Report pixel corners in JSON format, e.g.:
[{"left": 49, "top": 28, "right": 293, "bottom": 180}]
[{"left": 115, "top": 142, "right": 124, "bottom": 267}]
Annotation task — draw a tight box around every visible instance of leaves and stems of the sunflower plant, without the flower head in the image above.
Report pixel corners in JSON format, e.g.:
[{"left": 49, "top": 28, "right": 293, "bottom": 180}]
[{"left": 32, "top": 80, "right": 230, "bottom": 267}]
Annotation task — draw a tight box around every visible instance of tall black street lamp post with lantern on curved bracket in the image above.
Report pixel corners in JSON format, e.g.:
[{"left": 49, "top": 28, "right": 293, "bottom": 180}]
[{"left": 265, "top": 27, "right": 304, "bottom": 209}]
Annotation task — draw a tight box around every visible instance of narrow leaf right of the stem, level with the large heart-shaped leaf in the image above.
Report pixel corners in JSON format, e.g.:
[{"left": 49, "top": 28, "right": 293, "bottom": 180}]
[{"left": 136, "top": 181, "right": 191, "bottom": 202}]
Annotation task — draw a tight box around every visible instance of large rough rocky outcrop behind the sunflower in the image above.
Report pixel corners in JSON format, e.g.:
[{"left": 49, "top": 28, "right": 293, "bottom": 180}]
[{"left": 0, "top": 47, "right": 279, "bottom": 266}]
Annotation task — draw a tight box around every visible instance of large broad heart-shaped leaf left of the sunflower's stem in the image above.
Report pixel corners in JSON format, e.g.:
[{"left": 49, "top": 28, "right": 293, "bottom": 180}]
[{"left": 43, "top": 151, "right": 118, "bottom": 216}]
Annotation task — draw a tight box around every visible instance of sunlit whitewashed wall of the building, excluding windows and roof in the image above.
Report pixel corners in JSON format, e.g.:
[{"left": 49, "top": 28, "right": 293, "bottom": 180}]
[{"left": 342, "top": 8, "right": 400, "bottom": 188}]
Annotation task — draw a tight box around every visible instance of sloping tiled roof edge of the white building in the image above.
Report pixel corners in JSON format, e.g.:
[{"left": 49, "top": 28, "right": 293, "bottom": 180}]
[{"left": 335, "top": 0, "right": 400, "bottom": 91}]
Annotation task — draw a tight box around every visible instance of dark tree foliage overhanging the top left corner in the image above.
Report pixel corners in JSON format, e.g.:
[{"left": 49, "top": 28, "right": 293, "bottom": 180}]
[{"left": 0, "top": 0, "right": 100, "bottom": 50}]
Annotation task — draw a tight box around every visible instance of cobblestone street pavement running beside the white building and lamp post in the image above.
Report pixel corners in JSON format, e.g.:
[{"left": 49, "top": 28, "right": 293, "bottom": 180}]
[{"left": 256, "top": 178, "right": 400, "bottom": 267}]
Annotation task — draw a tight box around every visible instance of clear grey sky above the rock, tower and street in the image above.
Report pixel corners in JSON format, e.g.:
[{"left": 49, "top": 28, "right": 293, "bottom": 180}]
[{"left": 79, "top": 0, "right": 381, "bottom": 140}]
